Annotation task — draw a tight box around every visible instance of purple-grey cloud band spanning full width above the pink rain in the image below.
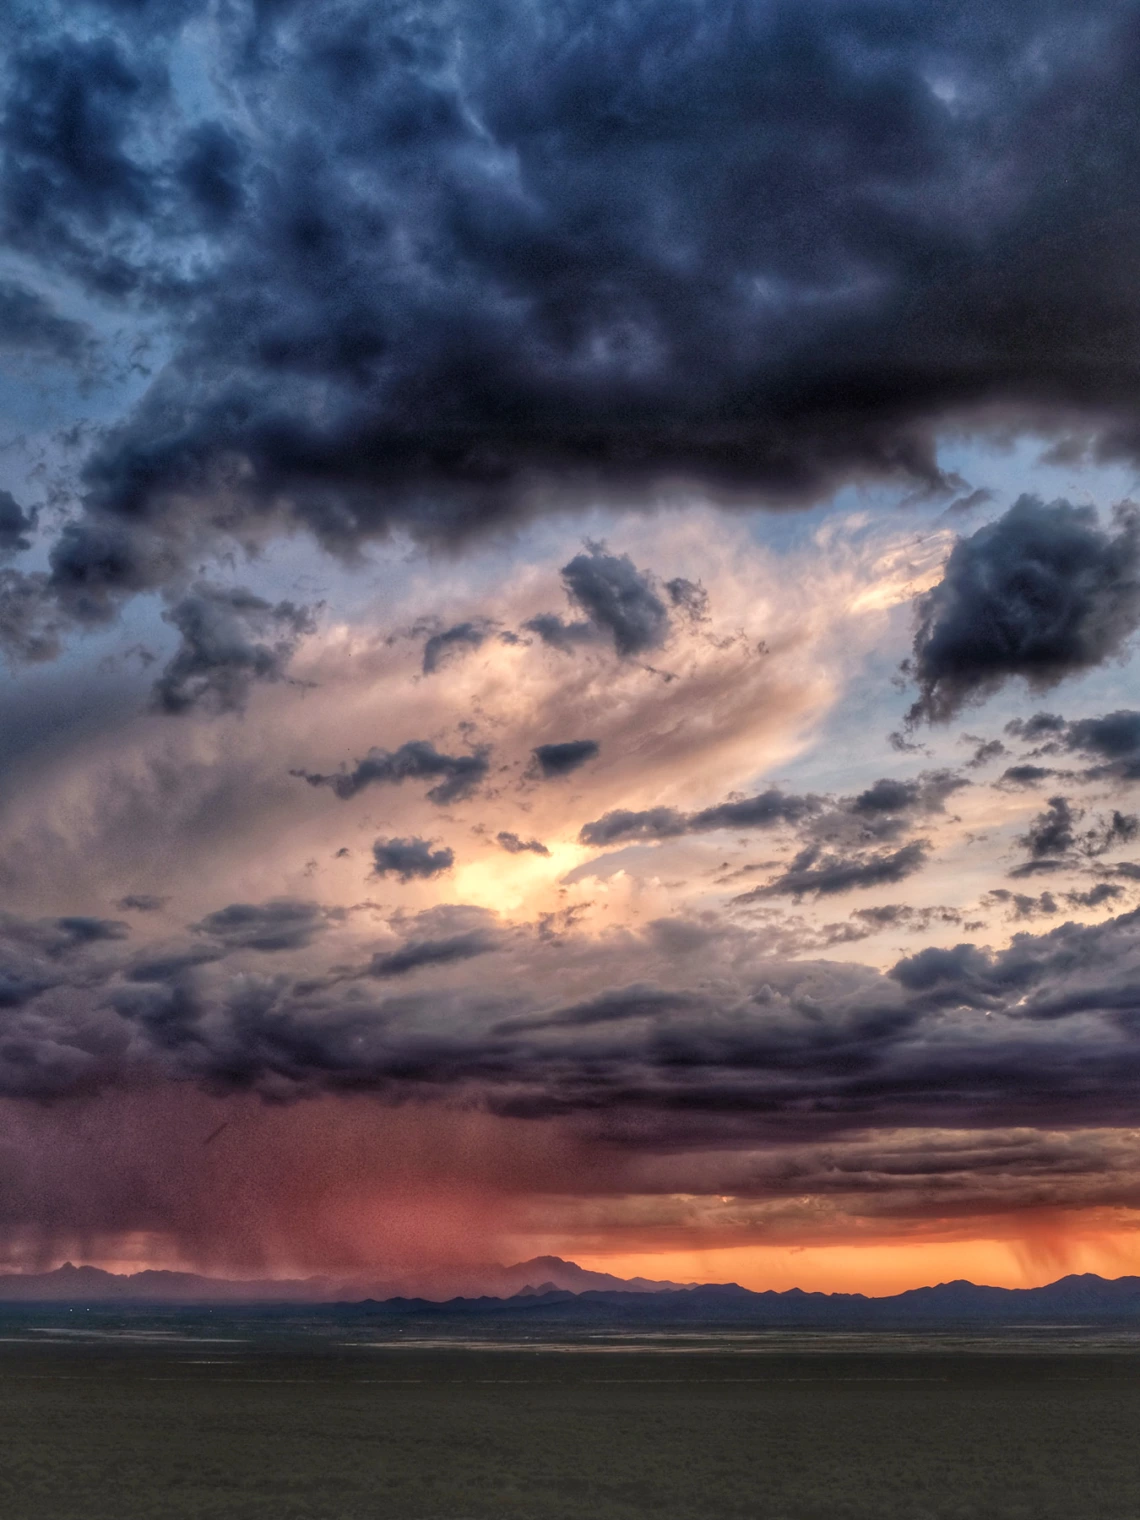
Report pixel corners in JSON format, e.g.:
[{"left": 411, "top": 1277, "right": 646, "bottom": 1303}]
[{"left": 0, "top": 901, "right": 1140, "bottom": 1138}]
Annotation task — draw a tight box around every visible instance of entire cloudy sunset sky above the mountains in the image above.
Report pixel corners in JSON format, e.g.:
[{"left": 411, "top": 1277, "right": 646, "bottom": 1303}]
[{"left": 0, "top": 0, "right": 1140, "bottom": 1290}]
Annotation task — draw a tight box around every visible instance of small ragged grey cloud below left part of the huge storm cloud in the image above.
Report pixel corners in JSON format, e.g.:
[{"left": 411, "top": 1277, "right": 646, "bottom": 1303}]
[{"left": 154, "top": 584, "right": 316, "bottom": 714}]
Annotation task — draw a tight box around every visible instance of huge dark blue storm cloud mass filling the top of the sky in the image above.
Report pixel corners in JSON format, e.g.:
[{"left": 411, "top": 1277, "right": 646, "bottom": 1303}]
[{"left": 11, "top": 0, "right": 1140, "bottom": 635}]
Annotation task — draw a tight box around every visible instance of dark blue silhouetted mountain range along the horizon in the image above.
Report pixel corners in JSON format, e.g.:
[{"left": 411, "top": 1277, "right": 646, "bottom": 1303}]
[{"left": 0, "top": 1257, "right": 1140, "bottom": 1328}]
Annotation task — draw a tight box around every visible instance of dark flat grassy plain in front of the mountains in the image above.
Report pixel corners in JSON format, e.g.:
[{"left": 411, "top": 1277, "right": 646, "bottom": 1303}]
[{"left": 0, "top": 1310, "right": 1140, "bottom": 1520}]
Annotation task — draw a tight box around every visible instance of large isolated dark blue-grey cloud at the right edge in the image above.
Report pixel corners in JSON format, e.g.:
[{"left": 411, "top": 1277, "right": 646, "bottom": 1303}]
[{"left": 907, "top": 496, "right": 1140, "bottom": 724}]
